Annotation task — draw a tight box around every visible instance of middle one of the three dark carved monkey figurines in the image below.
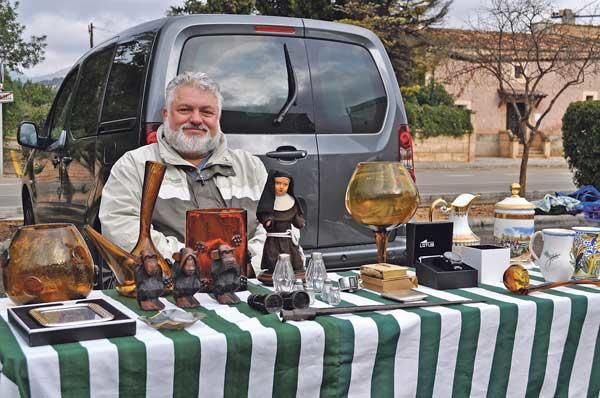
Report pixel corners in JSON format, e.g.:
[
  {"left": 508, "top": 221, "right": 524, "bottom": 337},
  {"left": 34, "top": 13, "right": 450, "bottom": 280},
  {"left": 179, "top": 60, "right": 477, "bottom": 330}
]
[{"left": 173, "top": 247, "right": 207, "bottom": 308}]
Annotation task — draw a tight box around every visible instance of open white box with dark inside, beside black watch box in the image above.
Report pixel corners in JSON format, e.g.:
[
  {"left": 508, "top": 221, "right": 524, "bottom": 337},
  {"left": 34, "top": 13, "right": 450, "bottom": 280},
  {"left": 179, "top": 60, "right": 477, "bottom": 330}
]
[{"left": 461, "top": 245, "right": 510, "bottom": 284}]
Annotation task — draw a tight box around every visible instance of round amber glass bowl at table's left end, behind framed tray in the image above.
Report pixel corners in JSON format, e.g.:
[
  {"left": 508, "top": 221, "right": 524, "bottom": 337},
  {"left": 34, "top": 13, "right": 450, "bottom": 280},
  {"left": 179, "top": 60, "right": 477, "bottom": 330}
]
[{"left": 2, "top": 224, "right": 94, "bottom": 304}]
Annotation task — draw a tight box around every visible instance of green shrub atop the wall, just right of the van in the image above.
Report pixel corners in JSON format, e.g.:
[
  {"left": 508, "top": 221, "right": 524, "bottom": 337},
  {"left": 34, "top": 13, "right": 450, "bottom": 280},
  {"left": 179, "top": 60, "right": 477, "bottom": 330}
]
[{"left": 402, "top": 83, "right": 473, "bottom": 138}]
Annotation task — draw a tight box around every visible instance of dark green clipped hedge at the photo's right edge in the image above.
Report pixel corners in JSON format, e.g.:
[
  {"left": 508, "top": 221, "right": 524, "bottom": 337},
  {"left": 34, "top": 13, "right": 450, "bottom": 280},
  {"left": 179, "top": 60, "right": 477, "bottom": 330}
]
[{"left": 562, "top": 101, "right": 600, "bottom": 188}]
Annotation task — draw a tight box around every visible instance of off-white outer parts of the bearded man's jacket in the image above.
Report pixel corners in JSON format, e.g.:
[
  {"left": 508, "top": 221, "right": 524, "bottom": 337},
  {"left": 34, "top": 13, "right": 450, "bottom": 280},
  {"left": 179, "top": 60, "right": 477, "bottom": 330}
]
[{"left": 99, "top": 126, "right": 267, "bottom": 274}]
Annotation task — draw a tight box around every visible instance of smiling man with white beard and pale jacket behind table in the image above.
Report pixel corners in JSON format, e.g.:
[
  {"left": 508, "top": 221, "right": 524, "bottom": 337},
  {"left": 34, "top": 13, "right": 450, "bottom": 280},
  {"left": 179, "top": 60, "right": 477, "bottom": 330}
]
[{"left": 99, "top": 72, "right": 267, "bottom": 272}]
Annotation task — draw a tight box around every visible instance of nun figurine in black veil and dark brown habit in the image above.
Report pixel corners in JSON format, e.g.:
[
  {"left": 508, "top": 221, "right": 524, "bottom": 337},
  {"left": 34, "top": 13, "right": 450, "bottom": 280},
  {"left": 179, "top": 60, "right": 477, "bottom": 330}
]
[{"left": 256, "top": 170, "right": 305, "bottom": 279}]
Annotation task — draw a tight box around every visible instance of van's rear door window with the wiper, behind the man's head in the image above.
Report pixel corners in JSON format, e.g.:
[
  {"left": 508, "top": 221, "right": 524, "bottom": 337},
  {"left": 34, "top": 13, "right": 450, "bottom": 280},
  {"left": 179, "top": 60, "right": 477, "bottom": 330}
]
[{"left": 179, "top": 35, "right": 314, "bottom": 134}]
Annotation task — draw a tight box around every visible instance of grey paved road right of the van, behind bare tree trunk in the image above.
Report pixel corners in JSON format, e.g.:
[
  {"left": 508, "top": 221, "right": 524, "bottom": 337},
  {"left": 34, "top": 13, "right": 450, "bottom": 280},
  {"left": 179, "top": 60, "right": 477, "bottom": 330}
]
[{"left": 417, "top": 167, "right": 575, "bottom": 196}]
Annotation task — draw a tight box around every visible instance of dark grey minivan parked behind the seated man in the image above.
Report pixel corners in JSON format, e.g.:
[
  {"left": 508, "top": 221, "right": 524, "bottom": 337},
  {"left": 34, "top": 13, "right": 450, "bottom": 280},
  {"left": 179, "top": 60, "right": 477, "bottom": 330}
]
[{"left": 19, "top": 15, "right": 408, "bottom": 282}]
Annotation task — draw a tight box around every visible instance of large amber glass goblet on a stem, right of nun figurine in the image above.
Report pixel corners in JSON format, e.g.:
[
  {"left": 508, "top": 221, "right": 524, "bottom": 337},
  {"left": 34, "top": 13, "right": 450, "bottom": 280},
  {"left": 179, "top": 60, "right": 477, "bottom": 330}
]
[{"left": 346, "top": 162, "right": 420, "bottom": 263}]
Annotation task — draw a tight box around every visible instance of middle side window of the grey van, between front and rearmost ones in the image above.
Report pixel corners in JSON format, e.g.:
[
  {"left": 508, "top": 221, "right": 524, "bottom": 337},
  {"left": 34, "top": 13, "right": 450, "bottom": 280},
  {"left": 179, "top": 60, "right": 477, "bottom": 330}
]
[{"left": 69, "top": 46, "right": 114, "bottom": 138}]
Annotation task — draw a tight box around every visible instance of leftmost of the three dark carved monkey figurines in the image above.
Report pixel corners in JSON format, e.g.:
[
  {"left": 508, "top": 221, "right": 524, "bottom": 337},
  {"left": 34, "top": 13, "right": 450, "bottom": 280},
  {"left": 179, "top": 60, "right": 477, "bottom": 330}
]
[{"left": 135, "top": 250, "right": 165, "bottom": 311}]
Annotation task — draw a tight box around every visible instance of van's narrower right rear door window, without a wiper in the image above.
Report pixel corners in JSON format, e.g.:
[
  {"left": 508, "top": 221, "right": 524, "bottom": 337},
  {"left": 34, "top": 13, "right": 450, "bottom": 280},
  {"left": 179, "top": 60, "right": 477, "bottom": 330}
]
[{"left": 307, "top": 40, "right": 387, "bottom": 134}]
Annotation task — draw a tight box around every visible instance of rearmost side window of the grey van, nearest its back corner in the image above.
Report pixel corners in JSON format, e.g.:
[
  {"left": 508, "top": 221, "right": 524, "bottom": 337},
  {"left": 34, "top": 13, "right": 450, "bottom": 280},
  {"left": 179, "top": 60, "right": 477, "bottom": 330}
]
[{"left": 101, "top": 34, "right": 154, "bottom": 122}]
